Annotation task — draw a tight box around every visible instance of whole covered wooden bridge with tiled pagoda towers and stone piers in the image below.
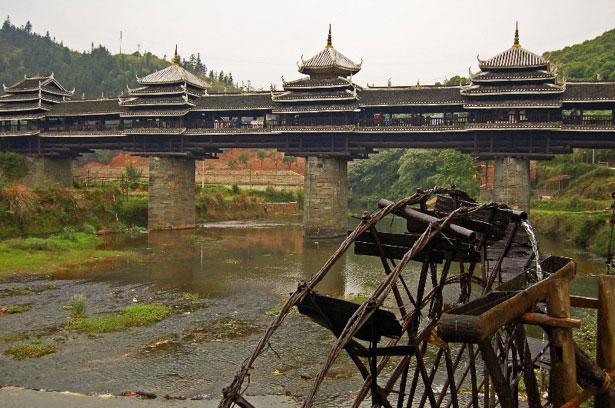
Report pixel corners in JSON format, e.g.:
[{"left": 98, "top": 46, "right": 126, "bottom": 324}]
[{"left": 0, "top": 24, "right": 615, "bottom": 238}]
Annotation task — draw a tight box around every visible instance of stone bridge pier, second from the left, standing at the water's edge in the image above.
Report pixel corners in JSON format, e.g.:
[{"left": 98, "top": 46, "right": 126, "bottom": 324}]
[{"left": 147, "top": 157, "right": 196, "bottom": 230}]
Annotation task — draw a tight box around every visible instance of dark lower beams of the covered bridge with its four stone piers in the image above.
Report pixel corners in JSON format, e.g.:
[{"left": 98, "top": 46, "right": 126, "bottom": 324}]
[{"left": 0, "top": 129, "right": 615, "bottom": 238}]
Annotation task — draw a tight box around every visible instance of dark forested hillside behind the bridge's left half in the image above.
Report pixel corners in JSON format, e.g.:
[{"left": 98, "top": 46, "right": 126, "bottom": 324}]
[{"left": 0, "top": 18, "right": 237, "bottom": 98}]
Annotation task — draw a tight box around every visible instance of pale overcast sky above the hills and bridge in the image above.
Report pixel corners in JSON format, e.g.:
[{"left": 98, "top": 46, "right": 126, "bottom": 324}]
[{"left": 0, "top": 0, "right": 615, "bottom": 88}]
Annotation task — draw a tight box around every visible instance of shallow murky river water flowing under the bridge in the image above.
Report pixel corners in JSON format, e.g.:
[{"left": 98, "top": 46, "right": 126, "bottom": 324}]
[{"left": 0, "top": 219, "right": 604, "bottom": 407}]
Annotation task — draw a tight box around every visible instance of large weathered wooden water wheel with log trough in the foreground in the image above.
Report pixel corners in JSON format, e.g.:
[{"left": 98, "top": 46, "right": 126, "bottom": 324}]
[{"left": 220, "top": 189, "right": 615, "bottom": 408}]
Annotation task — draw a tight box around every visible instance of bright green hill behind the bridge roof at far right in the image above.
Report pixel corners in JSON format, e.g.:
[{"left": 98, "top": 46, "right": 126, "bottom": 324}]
[{"left": 543, "top": 29, "right": 615, "bottom": 81}]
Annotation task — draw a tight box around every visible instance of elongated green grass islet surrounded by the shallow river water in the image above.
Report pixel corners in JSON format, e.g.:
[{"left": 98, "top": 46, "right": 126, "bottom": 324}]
[{"left": 67, "top": 304, "right": 171, "bottom": 334}]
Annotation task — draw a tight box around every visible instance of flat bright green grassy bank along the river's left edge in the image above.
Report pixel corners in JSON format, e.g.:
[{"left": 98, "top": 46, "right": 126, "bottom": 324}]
[{"left": 0, "top": 230, "right": 128, "bottom": 277}]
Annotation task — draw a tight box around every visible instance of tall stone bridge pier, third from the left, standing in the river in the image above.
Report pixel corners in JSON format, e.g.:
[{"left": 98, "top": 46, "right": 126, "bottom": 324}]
[{"left": 303, "top": 156, "right": 348, "bottom": 238}]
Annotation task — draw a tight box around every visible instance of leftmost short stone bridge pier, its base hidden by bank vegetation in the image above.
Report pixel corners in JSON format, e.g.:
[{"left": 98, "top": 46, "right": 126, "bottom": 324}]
[{"left": 22, "top": 156, "right": 73, "bottom": 188}]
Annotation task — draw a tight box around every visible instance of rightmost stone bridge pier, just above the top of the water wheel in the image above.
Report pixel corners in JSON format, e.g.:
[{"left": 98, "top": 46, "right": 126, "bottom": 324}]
[{"left": 493, "top": 157, "right": 530, "bottom": 211}]
